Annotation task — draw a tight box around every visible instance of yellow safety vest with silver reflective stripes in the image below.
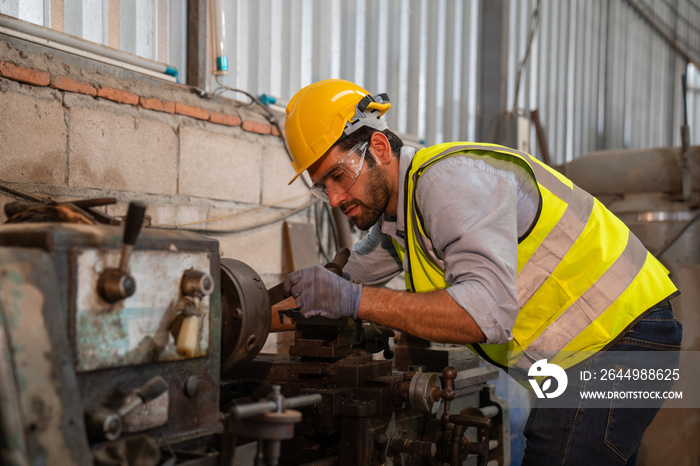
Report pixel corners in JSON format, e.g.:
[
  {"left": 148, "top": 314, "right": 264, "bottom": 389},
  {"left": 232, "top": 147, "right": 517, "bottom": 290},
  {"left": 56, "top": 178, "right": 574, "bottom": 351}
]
[{"left": 394, "top": 142, "right": 677, "bottom": 375}]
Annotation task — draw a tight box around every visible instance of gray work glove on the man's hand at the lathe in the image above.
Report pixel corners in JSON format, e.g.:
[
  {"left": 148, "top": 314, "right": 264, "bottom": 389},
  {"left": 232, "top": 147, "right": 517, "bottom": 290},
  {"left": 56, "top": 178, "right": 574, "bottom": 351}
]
[{"left": 284, "top": 265, "right": 362, "bottom": 319}]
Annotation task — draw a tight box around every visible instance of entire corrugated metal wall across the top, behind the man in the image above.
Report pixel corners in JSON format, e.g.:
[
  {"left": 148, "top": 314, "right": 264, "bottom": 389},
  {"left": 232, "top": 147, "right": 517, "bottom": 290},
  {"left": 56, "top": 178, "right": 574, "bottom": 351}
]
[{"left": 0, "top": 0, "right": 700, "bottom": 163}]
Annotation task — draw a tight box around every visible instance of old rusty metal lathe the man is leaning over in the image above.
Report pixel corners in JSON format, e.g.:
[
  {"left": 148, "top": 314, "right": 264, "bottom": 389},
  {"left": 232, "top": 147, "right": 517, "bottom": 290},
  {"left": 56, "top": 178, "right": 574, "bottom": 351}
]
[{"left": 0, "top": 198, "right": 509, "bottom": 466}]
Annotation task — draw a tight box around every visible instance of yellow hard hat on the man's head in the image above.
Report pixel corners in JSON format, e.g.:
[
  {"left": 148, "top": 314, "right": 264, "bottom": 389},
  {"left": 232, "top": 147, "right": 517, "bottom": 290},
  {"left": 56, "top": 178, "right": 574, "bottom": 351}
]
[{"left": 284, "top": 79, "right": 391, "bottom": 184}]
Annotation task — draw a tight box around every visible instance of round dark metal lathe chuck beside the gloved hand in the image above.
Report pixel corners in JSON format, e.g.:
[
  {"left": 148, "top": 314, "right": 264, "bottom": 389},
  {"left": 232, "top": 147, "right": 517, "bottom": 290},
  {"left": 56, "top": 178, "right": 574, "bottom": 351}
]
[{"left": 221, "top": 259, "right": 271, "bottom": 373}]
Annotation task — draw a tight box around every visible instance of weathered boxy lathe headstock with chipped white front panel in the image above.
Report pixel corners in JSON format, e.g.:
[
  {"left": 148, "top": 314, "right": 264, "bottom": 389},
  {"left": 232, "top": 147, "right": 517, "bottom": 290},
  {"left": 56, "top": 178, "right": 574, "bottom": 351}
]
[{"left": 0, "top": 217, "right": 223, "bottom": 466}]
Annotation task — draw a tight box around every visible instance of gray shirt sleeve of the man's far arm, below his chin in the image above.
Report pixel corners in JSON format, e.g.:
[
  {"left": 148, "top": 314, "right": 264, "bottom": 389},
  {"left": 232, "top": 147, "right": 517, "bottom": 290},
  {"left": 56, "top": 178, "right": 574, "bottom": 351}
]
[{"left": 343, "top": 224, "right": 402, "bottom": 286}]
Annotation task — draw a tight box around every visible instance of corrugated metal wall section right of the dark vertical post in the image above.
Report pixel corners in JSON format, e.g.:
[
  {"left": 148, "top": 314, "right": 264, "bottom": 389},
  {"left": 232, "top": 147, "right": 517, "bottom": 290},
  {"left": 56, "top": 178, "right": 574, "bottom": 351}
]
[{"left": 508, "top": 0, "right": 700, "bottom": 163}]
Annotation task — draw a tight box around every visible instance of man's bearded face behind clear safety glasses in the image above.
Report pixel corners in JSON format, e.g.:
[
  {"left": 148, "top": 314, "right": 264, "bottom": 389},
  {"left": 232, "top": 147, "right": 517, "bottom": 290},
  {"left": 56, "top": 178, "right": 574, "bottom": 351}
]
[{"left": 308, "top": 141, "right": 391, "bottom": 230}]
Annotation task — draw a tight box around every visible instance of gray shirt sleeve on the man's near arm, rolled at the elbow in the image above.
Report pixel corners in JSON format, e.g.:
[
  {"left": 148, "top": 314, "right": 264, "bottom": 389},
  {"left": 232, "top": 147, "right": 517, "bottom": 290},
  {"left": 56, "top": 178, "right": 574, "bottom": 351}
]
[{"left": 416, "top": 157, "right": 519, "bottom": 344}]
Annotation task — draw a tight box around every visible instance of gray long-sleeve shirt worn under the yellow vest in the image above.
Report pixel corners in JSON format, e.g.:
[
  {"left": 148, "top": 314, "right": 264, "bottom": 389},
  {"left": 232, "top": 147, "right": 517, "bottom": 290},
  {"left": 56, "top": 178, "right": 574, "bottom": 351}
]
[{"left": 344, "top": 147, "right": 539, "bottom": 344}]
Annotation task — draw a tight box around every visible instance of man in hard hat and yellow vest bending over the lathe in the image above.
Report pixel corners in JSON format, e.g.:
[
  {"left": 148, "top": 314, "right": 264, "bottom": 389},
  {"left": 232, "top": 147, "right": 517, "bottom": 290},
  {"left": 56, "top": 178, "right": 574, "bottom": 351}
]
[{"left": 285, "top": 80, "right": 681, "bottom": 465}]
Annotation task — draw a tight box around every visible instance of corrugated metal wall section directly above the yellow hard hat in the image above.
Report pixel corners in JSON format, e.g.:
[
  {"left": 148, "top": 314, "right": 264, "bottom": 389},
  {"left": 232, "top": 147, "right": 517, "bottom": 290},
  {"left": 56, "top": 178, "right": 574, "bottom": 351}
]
[{"left": 211, "top": 0, "right": 479, "bottom": 142}]
